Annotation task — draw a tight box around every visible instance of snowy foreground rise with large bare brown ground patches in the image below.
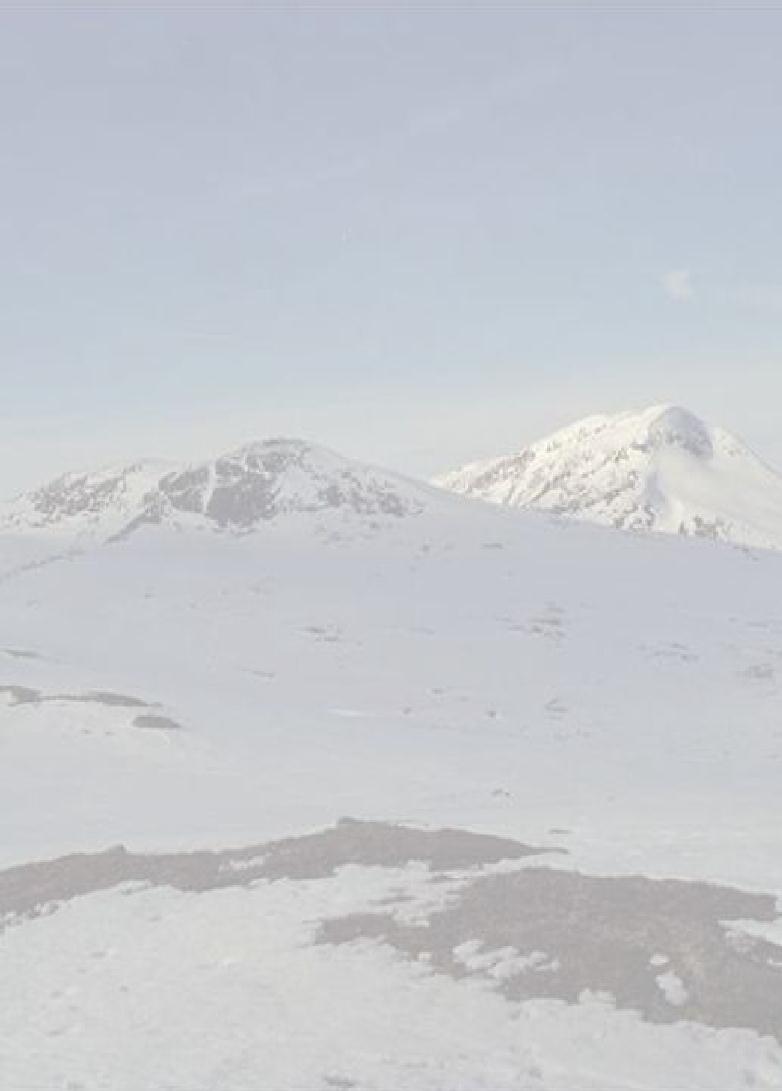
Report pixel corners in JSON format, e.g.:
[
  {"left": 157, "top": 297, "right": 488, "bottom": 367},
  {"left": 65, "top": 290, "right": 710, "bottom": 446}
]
[{"left": 0, "top": 824, "right": 782, "bottom": 1091}]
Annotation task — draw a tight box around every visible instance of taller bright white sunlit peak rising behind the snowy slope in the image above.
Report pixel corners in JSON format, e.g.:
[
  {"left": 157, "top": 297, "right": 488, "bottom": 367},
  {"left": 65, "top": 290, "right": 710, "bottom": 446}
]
[{"left": 435, "top": 406, "right": 782, "bottom": 549}]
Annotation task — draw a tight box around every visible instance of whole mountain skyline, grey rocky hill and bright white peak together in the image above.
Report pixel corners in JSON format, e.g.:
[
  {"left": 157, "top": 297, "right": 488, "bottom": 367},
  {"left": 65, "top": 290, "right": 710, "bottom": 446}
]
[{"left": 6, "top": 405, "right": 782, "bottom": 550}]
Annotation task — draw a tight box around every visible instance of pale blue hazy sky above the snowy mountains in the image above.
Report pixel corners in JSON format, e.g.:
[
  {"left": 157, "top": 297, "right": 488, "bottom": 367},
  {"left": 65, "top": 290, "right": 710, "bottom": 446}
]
[{"left": 0, "top": 2, "right": 782, "bottom": 492}]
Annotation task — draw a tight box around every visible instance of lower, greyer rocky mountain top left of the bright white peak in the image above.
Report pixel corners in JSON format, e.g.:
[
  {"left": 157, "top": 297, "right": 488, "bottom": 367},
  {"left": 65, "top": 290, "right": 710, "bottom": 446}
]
[{"left": 0, "top": 439, "right": 425, "bottom": 538}]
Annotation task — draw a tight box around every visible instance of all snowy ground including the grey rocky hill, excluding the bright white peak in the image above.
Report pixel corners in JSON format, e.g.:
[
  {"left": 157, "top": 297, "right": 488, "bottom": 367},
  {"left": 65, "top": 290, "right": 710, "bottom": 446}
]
[{"left": 0, "top": 441, "right": 782, "bottom": 1091}]
